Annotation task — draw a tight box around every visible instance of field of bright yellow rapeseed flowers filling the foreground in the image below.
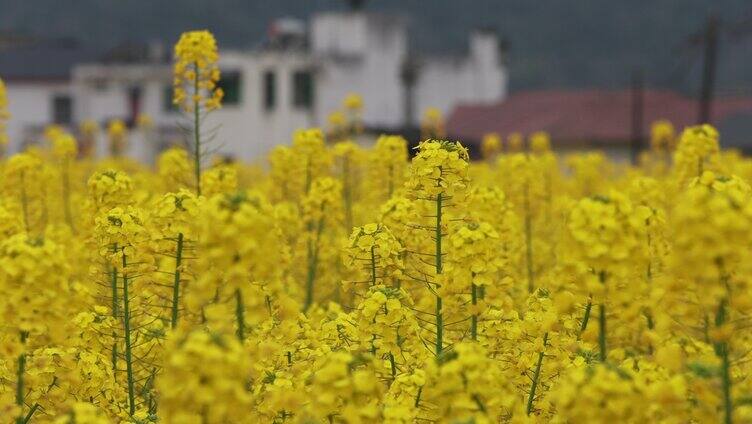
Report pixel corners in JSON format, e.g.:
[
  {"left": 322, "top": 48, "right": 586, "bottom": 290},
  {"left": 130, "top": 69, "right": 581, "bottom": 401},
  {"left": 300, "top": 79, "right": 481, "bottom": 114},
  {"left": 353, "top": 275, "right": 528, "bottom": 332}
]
[{"left": 0, "top": 38, "right": 752, "bottom": 424}]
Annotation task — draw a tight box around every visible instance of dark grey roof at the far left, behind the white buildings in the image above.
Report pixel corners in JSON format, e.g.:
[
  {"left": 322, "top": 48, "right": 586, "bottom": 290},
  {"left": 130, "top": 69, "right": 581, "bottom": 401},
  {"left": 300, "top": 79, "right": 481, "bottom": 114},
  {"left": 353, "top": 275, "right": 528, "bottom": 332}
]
[{"left": 0, "top": 40, "right": 99, "bottom": 81}]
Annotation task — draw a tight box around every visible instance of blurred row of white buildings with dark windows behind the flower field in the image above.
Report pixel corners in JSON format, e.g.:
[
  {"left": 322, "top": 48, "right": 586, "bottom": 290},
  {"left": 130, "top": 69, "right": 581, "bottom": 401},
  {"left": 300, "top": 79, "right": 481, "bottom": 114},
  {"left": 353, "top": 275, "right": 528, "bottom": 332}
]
[{"left": 0, "top": 6, "right": 507, "bottom": 161}]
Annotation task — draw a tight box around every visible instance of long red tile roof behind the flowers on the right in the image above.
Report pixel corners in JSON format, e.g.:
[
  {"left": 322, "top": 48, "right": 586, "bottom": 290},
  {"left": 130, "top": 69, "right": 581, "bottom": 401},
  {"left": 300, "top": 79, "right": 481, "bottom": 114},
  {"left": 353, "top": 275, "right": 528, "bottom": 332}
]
[{"left": 447, "top": 90, "right": 752, "bottom": 145}]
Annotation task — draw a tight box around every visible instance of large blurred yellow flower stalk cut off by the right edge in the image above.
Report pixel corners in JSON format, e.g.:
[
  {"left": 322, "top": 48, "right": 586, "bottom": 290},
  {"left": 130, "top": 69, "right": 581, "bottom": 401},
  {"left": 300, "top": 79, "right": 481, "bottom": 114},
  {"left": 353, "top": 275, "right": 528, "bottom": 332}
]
[{"left": 670, "top": 172, "right": 752, "bottom": 424}]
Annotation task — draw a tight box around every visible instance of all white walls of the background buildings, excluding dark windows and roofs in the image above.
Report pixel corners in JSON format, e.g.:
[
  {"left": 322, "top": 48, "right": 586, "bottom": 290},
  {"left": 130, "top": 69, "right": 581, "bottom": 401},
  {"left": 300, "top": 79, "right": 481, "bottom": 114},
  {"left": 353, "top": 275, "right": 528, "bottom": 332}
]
[{"left": 2, "top": 12, "right": 507, "bottom": 163}]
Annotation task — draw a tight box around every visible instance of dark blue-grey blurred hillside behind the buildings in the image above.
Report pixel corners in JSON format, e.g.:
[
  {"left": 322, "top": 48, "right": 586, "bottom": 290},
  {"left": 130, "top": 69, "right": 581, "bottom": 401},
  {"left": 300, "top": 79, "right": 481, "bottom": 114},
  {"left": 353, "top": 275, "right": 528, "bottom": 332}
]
[{"left": 0, "top": 0, "right": 752, "bottom": 94}]
